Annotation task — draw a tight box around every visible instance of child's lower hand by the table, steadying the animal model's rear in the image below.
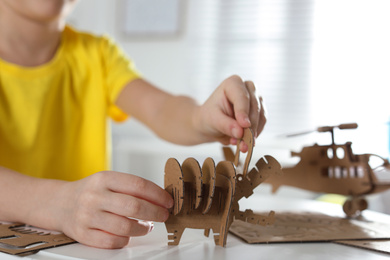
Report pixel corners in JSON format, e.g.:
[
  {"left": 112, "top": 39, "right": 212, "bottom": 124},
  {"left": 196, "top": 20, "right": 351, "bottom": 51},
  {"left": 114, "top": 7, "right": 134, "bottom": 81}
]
[{"left": 53, "top": 171, "right": 173, "bottom": 248}]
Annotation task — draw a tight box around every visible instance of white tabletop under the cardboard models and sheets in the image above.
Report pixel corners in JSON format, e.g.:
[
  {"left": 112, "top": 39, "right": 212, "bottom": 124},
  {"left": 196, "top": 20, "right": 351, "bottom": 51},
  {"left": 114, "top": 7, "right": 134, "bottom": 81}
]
[{"left": 0, "top": 195, "right": 390, "bottom": 260}]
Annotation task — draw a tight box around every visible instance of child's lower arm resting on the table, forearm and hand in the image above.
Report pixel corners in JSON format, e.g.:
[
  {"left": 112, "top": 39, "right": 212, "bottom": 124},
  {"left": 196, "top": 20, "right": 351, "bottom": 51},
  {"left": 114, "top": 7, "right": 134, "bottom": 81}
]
[{"left": 0, "top": 167, "right": 173, "bottom": 248}]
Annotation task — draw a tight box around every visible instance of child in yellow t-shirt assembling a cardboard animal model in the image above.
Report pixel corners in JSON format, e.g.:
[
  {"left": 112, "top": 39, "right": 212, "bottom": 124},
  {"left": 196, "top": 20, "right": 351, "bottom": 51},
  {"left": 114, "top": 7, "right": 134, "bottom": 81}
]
[{"left": 0, "top": 0, "right": 265, "bottom": 248}]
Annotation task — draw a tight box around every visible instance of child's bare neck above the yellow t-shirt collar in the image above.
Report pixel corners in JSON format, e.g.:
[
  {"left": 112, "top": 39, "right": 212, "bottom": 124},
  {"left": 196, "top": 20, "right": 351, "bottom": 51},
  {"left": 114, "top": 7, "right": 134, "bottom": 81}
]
[{"left": 0, "top": 8, "right": 64, "bottom": 67}]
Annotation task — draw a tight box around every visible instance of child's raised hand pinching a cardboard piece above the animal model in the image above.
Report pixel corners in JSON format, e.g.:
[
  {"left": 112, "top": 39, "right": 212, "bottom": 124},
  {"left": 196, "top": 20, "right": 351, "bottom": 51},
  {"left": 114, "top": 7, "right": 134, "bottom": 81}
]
[{"left": 196, "top": 76, "right": 266, "bottom": 152}]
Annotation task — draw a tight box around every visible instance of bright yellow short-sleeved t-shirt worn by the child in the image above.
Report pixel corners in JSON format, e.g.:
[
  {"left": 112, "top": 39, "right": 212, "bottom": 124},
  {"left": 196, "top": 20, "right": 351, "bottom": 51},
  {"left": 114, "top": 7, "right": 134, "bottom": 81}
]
[{"left": 0, "top": 26, "right": 139, "bottom": 180}]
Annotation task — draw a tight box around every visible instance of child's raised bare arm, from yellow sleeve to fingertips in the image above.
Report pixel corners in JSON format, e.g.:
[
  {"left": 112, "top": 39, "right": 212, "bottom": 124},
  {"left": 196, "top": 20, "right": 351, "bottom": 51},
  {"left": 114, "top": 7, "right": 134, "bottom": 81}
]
[{"left": 117, "top": 76, "right": 266, "bottom": 149}]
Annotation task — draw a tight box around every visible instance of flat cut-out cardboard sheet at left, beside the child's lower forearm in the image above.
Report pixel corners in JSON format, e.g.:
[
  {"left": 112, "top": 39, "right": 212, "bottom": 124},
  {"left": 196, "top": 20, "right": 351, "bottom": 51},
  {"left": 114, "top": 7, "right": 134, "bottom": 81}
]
[{"left": 0, "top": 223, "right": 76, "bottom": 256}]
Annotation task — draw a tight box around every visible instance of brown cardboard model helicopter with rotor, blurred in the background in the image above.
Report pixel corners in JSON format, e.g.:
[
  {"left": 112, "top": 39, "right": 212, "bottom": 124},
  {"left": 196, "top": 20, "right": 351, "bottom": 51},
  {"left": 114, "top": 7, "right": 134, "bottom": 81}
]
[{"left": 258, "top": 123, "right": 390, "bottom": 217}]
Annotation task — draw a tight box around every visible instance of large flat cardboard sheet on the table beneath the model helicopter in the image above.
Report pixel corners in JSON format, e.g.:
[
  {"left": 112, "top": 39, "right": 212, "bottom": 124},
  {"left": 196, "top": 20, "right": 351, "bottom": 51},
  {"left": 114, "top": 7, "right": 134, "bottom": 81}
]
[{"left": 230, "top": 212, "right": 390, "bottom": 243}]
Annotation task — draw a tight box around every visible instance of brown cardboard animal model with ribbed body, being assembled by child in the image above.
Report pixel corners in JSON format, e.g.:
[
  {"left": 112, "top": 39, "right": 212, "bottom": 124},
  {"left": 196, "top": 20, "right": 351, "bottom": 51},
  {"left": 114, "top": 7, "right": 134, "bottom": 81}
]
[{"left": 164, "top": 129, "right": 281, "bottom": 246}]
